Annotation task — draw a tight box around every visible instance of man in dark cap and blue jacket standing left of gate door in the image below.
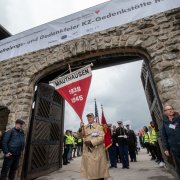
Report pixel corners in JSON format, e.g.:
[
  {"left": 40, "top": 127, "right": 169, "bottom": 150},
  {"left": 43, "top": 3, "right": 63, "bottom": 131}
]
[{"left": 0, "top": 119, "right": 25, "bottom": 180}]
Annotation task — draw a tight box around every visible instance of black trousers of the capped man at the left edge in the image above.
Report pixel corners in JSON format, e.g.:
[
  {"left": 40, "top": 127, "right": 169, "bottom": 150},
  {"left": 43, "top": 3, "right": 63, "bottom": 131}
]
[{"left": 0, "top": 155, "right": 20, "bottom": 180}]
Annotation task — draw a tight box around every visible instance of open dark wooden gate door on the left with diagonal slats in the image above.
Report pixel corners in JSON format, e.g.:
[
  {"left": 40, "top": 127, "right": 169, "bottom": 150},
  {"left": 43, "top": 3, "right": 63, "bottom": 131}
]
[{"left": 25, "top": 83, "right": 64, "bottom": 179}]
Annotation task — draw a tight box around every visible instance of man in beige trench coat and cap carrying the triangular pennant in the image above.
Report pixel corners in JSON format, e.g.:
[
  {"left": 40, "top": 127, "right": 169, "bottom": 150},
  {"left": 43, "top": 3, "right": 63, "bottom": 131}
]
[{"left": 80, "top": 113, "right": 109, "bottom": 180}]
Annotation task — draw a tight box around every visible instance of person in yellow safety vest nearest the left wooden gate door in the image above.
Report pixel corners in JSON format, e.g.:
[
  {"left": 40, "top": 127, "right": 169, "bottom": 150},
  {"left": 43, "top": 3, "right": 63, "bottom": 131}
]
[{"left": 63, "top": 130, "right": 71, "bottom": 165}]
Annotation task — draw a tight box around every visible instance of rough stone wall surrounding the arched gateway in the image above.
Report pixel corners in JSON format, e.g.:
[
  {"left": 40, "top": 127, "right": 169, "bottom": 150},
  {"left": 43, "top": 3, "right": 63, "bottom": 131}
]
[{"left": 0, "top": 9, "right": 180, "bottom": 178}]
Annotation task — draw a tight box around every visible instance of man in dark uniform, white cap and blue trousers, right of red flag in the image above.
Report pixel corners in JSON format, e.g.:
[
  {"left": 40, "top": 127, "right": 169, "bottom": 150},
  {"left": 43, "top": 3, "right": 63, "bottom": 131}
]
[{"left": 116, "top": 121, "right": 129, "bottom": 169}]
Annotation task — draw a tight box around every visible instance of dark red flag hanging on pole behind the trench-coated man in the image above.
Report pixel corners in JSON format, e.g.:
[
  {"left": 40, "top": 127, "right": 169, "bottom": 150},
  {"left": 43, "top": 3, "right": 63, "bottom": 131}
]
[{"left": 101, "top": 111, "right": 112, "bottom": 149}]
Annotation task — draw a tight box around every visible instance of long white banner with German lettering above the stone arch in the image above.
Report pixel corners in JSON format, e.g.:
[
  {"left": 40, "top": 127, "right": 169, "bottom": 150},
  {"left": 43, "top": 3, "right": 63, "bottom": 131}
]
[{"left": 0, "top": 0, "right": 180, "bottom": 61}]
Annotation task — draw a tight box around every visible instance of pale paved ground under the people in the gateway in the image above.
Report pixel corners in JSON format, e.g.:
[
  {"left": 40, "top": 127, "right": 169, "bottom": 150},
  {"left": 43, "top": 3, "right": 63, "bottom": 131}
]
[{"left": 37, "top": 150, "right": 177, "bottom": 180}]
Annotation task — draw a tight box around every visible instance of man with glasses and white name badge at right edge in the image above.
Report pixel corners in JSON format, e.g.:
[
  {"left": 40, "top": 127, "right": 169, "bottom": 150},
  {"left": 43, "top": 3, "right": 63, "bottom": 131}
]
[{"left": 162, "top": 106, "right": 180, "bottom": 175}]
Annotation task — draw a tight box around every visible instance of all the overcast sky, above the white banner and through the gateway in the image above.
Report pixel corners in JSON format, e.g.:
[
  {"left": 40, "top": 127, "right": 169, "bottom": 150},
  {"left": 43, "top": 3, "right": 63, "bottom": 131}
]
[{"left": 0, "top": 0, "right": 151, "bottom": 130}]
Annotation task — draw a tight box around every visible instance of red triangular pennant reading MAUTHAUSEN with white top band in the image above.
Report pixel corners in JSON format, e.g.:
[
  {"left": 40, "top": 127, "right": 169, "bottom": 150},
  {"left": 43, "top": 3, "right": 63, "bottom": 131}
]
[{"left": 50, "top": 65, "right": 92, "bottom": 120}]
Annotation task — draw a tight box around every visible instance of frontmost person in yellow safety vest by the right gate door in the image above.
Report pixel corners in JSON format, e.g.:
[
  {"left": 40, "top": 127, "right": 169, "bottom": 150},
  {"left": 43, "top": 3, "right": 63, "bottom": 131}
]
[{"left": 150, "top": 121, "right": 165, "bottom": 167}]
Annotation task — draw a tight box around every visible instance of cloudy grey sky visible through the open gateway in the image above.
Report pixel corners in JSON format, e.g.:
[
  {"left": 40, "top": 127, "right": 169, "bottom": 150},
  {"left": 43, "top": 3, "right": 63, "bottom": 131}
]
[{"left": 65, "top": 61, "right": 151, "bottom": 130}]
